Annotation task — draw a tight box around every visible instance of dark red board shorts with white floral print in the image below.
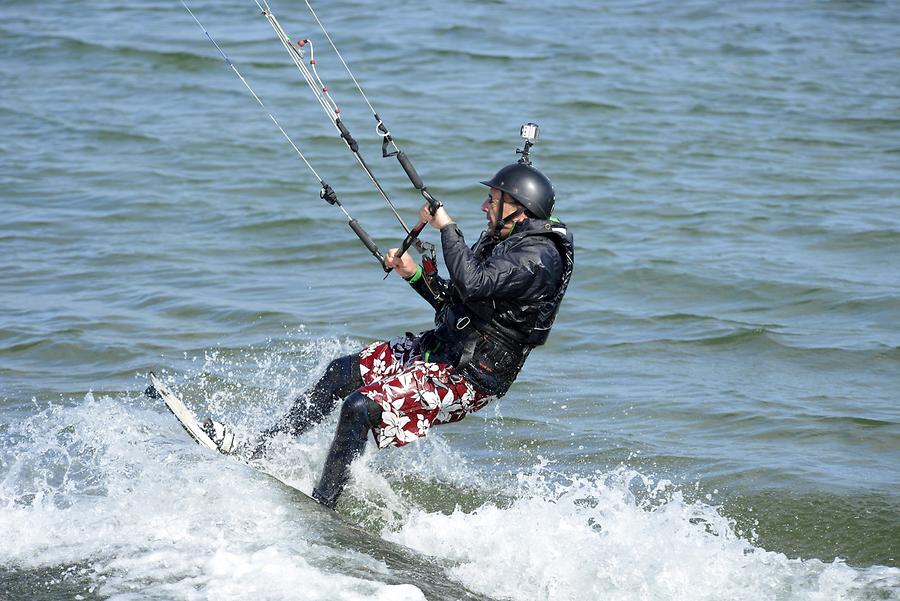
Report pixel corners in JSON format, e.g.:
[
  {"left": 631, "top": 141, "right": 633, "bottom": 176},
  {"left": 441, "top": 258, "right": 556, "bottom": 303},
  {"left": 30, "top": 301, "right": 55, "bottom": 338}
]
[{"left": 358, "top": 333, "right": 494, "bottom": 449}]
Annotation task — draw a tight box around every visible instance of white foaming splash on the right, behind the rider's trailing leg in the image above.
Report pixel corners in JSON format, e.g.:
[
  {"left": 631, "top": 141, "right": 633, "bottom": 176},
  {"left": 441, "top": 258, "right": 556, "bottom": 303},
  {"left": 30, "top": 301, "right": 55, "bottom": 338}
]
[{"left": 374, "top": 468, "right": 900, "bottom": 601}]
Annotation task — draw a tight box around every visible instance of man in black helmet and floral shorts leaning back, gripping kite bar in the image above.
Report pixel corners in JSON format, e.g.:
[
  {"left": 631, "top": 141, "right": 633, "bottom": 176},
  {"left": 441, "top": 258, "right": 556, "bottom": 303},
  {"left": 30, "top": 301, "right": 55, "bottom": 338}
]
[{"left": 204, "top": 146, "right": 574, "bottom": 508}]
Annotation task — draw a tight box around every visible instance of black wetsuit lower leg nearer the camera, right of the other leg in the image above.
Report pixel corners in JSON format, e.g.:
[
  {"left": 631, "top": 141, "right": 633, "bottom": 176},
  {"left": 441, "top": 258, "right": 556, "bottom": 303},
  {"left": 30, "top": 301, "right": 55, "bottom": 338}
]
[{"left": 313, "top": 391, "right": 381, "bottom": 509}]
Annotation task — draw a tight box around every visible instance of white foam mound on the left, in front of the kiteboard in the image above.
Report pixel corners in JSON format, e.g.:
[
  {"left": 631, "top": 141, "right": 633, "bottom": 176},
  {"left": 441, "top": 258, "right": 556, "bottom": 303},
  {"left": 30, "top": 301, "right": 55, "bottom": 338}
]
[{"left": 0, "top": 395, "right": 424, "bottom": 601}]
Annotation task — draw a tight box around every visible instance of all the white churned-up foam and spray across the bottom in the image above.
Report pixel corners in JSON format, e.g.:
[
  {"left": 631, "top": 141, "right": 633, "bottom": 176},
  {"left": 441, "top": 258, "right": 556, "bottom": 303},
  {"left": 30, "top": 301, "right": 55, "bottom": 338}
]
[{"left": 0, "top": 366, "right": 900, "bottom": 601}]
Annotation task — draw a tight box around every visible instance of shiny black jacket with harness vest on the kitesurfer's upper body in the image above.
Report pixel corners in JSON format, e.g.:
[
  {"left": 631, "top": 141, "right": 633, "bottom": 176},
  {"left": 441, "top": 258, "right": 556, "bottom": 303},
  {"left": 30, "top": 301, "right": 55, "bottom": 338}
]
[{"left": 412, "top": 219, "right": 574, "bottom": 396}]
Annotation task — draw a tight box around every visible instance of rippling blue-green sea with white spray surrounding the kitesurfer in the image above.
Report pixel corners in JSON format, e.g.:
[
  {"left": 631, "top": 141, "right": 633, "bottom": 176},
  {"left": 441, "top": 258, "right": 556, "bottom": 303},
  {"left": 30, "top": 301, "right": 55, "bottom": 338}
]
[{"left": 0, "top": 0, "right": 900, "bottom": 601}]
